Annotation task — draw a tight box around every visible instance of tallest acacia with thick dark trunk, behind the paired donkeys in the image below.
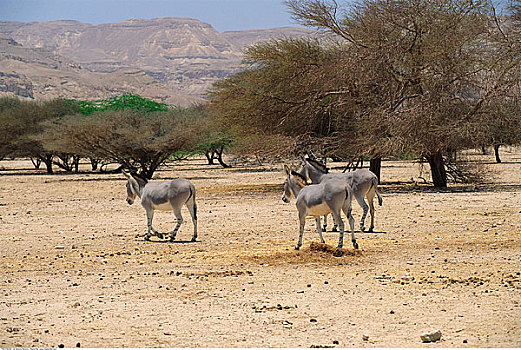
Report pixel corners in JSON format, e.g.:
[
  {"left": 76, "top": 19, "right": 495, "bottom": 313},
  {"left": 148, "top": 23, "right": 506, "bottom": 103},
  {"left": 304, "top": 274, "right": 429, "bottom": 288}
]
[{"left": 286, "top": 0, "right": 512, "bottom": 187}]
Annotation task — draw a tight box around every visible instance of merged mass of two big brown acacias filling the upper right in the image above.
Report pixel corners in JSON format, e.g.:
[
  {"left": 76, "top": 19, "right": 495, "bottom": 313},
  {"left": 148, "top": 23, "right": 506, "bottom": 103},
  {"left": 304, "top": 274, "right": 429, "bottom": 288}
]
[{"left": 211, "top": 0, "right": 521, "bottom": 187}]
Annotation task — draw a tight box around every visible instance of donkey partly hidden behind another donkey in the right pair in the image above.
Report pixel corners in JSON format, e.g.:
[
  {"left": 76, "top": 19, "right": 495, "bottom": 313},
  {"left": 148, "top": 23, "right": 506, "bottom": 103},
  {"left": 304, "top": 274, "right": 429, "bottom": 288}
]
[{"left": 299, "top": 158, "right": 383, "bottom": 232}]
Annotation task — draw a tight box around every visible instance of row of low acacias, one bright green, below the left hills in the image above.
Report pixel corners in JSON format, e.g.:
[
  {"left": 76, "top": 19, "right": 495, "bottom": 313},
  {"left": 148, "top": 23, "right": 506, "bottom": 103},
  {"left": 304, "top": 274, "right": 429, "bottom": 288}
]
[{"left": 0, "top": 95, "right": 232, "bottom": 179}]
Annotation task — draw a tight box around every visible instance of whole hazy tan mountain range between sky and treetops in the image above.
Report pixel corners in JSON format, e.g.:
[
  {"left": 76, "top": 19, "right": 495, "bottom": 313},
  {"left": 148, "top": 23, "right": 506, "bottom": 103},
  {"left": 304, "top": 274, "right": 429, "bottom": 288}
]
[{"left": 0, "top": 17, "right": 312, "bottom": 103}]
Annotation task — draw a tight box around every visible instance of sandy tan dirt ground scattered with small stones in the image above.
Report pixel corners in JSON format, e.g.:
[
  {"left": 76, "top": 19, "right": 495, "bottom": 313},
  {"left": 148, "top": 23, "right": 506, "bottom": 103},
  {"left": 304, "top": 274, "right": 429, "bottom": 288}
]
[{"left": 0, "top": 149, "right": 521, "bottom": 348}]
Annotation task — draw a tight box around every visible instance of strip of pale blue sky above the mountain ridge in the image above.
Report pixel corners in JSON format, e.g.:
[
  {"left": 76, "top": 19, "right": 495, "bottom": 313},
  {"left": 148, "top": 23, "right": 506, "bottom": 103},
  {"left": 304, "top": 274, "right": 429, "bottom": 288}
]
[{"left": 0, "top": 0, "right": 298, "bottom": 32}]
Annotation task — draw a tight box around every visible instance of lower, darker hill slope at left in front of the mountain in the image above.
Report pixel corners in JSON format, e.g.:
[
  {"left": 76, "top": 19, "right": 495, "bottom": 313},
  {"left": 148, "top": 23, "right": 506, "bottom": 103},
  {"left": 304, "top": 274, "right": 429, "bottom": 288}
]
[{"left": 0, "top": 37, "right": 202, "bottom": 106}]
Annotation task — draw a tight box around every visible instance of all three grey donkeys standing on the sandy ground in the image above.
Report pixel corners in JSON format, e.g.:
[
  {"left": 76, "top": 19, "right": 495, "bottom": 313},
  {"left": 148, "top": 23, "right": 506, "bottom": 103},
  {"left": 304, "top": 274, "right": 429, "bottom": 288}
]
[{"left": 123, "top": 158, "right": 382, "bottom": 250}]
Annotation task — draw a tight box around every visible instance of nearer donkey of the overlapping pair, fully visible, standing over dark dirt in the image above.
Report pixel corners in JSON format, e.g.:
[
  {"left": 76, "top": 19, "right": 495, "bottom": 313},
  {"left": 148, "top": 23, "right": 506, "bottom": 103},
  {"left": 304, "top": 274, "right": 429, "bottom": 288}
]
[{"left": 282, "top": 165, "right": 358, "bottom": 250}]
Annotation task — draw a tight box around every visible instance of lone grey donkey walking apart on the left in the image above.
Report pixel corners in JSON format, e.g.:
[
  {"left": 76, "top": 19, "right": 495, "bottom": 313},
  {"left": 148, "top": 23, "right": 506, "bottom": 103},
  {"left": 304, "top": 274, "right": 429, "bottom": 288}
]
[{"left": 123, "top": 171, "right": 197, "bottom": 242}]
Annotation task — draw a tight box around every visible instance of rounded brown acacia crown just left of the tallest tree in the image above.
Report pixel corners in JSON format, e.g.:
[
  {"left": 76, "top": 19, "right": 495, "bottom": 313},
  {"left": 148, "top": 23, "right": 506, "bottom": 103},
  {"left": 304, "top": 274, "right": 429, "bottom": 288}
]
[{"left": 210, "top": 38, "right": 353, "bottom": 157}]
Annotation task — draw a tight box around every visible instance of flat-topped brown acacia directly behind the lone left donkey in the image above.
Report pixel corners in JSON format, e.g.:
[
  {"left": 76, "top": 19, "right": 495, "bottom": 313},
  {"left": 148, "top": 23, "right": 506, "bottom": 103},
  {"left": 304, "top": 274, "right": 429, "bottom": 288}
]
[{"left": 41, "top": 108, "right": 200, "bottom": 179}]
